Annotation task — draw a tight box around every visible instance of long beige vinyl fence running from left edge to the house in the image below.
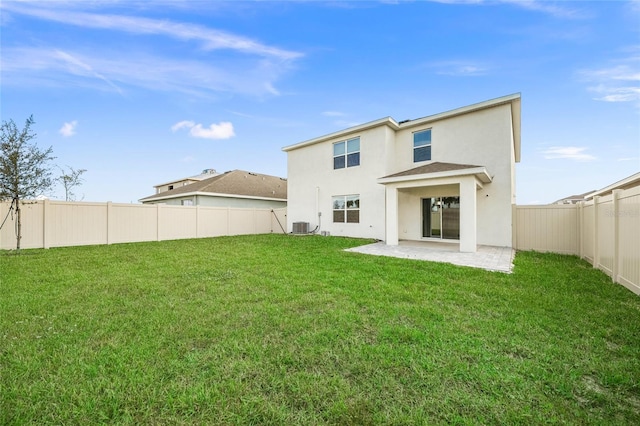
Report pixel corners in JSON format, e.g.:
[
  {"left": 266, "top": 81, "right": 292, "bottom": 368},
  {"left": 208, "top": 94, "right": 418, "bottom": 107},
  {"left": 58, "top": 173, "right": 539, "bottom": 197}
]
[{"left": 0, "top": 200, "right": 286, "bottom": 249}]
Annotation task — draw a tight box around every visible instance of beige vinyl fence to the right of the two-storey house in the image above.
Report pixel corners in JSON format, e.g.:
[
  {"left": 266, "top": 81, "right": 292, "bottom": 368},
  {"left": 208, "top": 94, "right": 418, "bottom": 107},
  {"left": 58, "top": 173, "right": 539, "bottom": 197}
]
[{"left": 513, "top": 186, "right": 640, "bottom": 294}]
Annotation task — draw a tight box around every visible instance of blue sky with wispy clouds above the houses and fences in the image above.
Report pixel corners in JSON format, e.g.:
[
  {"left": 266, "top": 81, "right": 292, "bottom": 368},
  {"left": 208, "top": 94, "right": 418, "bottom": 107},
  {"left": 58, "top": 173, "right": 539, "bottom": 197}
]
[{"left": 0, "top": 0, "right": 640, "bottom": 204}]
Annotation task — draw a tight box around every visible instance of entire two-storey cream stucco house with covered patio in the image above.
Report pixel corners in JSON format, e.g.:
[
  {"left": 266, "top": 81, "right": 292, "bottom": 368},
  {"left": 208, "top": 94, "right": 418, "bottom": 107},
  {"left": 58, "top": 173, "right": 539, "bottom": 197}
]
[{"left": 283, "top": 94, "right": 521, "bottom": 252}]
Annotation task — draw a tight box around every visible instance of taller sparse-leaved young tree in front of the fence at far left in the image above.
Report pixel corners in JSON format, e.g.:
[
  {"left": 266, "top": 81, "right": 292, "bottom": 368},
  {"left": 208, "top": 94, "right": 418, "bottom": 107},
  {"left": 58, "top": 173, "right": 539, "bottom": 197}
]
[{"left": 0, "top": 116, "right": 55, "bottom": 250}]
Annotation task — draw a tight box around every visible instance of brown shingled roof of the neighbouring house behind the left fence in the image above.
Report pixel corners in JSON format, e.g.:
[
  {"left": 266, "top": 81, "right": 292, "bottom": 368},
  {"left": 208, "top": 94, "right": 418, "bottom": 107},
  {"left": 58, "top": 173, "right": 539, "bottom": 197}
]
[{"left": 140, "top": 170, "right": 287, "bottom": 202}]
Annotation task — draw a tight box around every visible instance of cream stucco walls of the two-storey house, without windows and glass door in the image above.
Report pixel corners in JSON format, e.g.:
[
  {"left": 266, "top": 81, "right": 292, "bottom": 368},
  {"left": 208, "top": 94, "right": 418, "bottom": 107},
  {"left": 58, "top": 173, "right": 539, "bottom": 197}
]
[{"left": 284, "top": 95, "right": 520, "bottom": 247}]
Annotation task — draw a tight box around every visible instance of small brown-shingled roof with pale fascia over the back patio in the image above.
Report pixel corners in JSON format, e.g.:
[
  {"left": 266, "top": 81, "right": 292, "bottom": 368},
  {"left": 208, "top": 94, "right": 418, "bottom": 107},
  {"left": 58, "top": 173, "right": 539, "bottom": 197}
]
[{"left": 378, "top": 162, "right": 493, "bottom": 188}]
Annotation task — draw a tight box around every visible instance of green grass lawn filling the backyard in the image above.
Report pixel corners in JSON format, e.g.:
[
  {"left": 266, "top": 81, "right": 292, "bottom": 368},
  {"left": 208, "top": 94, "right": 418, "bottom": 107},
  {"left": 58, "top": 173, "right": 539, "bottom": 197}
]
[{"left": 0, "top": 235, "right": 640, "bottom": 425}]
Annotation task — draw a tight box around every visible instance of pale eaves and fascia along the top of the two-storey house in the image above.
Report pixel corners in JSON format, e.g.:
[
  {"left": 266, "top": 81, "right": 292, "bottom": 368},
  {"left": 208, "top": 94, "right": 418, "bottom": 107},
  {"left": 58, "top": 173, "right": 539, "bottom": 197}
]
[{"left": 282, "top": 93, "right": 521, "bottom": 163}]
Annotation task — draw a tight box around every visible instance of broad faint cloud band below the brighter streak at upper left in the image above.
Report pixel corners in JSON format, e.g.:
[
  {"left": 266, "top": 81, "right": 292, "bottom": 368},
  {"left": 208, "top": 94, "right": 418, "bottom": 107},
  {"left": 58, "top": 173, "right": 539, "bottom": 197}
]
[{"left": 2, "top": 47, "right": 289, "bottom": 98}]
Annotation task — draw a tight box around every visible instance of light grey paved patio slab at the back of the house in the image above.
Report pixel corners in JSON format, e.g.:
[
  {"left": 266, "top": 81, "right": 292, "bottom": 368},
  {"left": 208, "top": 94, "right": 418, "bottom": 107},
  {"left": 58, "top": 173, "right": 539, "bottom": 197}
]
[{"left": 346, "top": 241, "right": 515, "bottom": 273}]
